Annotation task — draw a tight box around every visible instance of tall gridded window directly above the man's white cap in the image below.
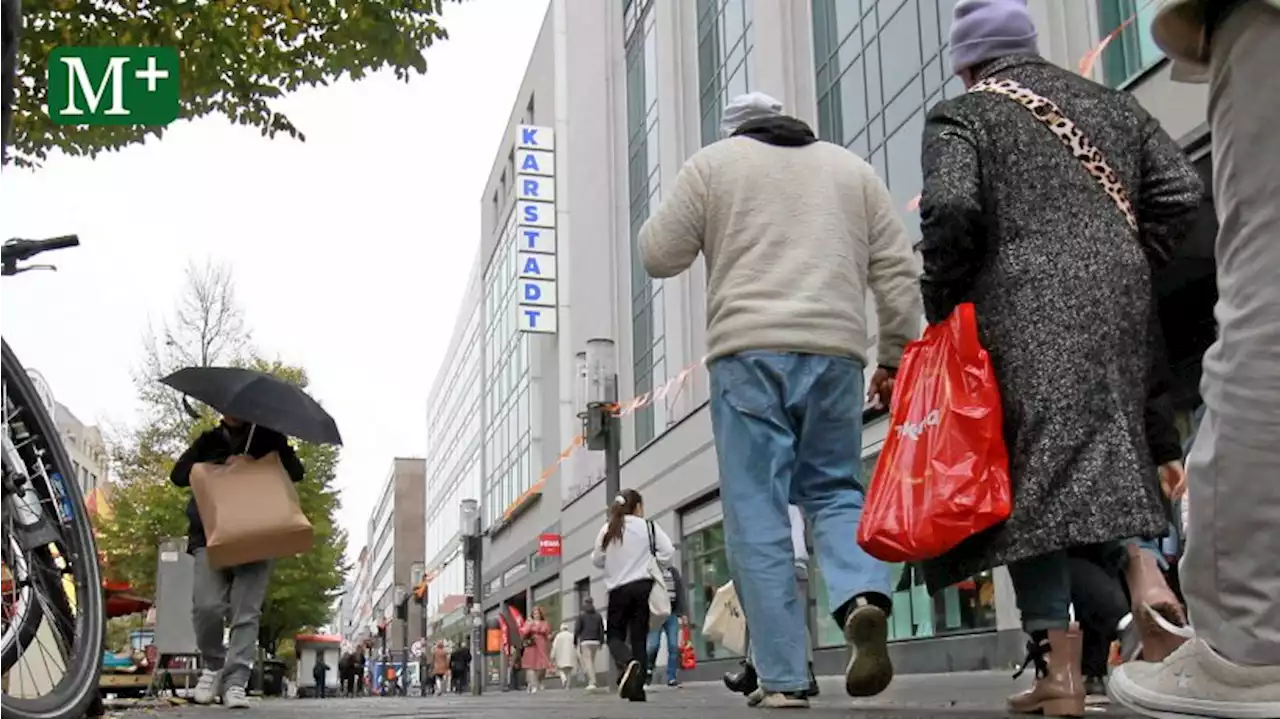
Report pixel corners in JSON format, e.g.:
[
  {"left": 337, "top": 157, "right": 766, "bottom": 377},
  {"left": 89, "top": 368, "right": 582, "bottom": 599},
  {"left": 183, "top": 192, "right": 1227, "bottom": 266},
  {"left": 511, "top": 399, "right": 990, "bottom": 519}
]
[{"left": 698, "top": 0, "right": 752, "bottom": 145}]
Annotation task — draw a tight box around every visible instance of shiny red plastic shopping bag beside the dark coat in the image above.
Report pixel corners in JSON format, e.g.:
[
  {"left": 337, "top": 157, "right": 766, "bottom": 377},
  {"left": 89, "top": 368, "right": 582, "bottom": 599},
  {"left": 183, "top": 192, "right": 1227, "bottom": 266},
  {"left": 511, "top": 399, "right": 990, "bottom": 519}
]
[{"left": 858, "top": 303, "right": 1012, "bottom": 562}]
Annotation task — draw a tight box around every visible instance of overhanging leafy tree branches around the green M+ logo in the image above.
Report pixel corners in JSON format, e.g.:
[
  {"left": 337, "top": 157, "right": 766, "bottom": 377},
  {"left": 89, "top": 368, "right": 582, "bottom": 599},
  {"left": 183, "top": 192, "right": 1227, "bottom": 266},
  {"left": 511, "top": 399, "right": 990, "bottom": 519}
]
[{"left": 14, "top": 0, "right": 460, "bottom": 165}]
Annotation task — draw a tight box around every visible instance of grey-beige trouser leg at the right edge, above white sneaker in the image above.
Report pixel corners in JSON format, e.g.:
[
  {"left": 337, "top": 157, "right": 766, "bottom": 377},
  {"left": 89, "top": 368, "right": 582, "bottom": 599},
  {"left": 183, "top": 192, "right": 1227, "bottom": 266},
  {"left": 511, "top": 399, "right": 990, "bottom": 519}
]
[{"left": 1181, "top": 1, "right": 1280, "bottom": 665}]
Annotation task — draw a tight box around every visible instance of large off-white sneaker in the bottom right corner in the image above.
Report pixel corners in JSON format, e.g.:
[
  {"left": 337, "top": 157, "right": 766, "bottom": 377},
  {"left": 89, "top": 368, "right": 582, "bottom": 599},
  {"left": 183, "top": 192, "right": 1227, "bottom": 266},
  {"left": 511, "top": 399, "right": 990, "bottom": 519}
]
[{"left": 1107, "top": 638, "right": 1280, "bottom": 719}]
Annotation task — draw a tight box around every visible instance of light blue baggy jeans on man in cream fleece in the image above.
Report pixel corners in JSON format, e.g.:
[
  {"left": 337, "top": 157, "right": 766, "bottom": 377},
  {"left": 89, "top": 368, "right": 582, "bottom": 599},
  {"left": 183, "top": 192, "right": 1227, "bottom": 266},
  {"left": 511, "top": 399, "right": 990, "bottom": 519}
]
[{"left": 709, "top": 352, "right": 891, "bottom": 692}]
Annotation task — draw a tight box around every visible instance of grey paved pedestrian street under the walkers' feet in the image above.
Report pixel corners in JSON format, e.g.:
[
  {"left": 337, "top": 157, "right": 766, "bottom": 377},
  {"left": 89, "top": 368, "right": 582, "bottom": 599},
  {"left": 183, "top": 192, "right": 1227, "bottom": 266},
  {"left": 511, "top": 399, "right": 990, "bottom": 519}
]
[{"left": 108, "top": 672, "right": 1152, "bottom": 719}]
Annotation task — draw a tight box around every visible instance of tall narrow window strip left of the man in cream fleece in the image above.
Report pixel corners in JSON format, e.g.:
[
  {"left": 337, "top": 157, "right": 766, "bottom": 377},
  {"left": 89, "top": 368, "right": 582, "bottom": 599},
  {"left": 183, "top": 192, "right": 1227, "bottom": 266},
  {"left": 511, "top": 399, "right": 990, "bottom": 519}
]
[{"left": 623, "top": 0, "right": 667, "bottom": 449}]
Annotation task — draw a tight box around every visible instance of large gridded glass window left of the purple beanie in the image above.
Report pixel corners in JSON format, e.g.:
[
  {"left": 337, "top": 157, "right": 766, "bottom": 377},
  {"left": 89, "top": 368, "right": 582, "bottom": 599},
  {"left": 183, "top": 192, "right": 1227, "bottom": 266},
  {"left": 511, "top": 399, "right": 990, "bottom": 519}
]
[{"left": 813, "top": 0, "right": 964, "bottom": 238}]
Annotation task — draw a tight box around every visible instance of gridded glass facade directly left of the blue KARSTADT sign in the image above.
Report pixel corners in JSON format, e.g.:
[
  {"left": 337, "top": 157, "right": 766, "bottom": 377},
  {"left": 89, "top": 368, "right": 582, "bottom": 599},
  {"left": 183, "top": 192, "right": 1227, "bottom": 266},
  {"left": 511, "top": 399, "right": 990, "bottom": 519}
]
[{"left": 484, "top": 207, "right": 538, "bottom": 527}]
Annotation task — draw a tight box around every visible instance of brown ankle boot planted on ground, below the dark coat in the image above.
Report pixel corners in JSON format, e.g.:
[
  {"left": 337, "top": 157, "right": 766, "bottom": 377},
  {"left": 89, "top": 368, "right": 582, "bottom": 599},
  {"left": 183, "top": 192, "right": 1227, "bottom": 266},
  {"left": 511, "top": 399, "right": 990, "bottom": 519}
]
[{"left": 1009, "top": 624, "right": 1084, "bottom": 716}]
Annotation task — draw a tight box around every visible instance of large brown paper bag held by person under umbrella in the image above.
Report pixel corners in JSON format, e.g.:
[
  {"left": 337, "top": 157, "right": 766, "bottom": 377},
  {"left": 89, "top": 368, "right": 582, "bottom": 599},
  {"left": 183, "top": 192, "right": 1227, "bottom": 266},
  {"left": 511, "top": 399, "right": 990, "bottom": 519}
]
[{"left": 191, "top": 452, "right": 315, "bottom": 569}]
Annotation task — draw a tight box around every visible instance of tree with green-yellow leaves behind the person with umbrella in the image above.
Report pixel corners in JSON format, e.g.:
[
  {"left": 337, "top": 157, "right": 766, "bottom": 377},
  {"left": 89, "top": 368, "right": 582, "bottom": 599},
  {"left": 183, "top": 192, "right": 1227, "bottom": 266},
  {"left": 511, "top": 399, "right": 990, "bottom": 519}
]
[{"left": 99, "top": 259, "right": 347, "bottom": 651}]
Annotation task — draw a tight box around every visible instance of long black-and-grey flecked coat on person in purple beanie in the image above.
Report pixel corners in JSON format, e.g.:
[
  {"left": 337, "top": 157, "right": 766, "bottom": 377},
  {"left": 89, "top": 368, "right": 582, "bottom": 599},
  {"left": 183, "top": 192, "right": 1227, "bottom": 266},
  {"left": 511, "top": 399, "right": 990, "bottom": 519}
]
[{"left": 920, "top": 58, "right": 1203, "bottom": 591}]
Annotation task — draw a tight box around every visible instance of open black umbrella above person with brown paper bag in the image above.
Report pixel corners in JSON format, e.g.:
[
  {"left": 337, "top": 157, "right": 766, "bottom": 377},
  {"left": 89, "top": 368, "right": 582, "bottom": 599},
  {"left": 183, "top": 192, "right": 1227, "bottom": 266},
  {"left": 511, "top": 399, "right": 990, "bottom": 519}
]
[{"left": 160, "top": 367, "right": 342, "bottom": 444}]
